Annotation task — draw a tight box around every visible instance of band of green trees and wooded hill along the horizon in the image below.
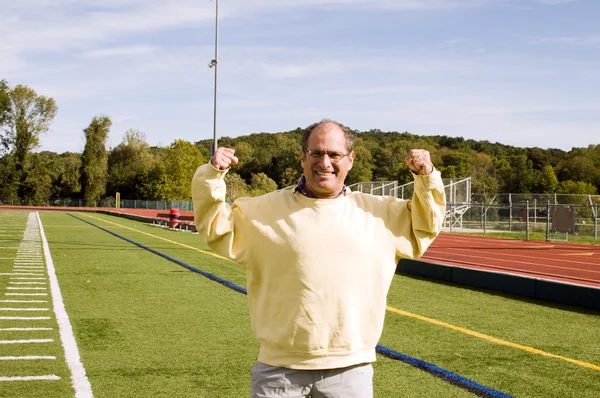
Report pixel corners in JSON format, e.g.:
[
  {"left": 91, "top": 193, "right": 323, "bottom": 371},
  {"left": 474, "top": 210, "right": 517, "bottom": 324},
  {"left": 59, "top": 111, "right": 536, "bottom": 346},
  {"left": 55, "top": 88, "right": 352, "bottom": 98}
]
[{"left": 0, "top": 80, "right": 600, "bottom": 206}]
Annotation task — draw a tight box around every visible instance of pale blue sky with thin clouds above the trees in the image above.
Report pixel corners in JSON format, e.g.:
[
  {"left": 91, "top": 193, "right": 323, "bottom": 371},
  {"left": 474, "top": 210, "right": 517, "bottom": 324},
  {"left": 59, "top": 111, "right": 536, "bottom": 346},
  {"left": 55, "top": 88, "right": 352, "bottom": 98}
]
[{"left": 0, "top": 0, "right": 600, "bottom": 153}]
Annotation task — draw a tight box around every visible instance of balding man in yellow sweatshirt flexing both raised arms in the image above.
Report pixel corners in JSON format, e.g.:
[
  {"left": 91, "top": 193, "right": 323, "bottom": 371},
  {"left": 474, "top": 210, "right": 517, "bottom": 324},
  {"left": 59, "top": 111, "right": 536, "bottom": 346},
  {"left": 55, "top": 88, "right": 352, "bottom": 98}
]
[{"left": 192, "top": 120, "right": 445, "bottom": 398}]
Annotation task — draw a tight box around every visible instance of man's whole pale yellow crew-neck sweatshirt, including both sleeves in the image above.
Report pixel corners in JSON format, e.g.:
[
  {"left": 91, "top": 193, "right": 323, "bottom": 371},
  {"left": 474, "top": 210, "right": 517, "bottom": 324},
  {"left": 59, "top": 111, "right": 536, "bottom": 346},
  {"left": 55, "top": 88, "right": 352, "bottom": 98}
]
[{"left": 192, "top": 164, "right": 446, "bottom": 369}]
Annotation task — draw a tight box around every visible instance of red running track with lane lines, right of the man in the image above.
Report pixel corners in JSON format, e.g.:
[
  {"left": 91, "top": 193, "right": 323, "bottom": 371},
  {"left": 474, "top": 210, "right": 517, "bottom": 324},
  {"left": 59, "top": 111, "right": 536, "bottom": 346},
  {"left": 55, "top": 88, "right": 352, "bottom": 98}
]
[{"left": 422, "top": 233, "right": 600, "bottom": 288}]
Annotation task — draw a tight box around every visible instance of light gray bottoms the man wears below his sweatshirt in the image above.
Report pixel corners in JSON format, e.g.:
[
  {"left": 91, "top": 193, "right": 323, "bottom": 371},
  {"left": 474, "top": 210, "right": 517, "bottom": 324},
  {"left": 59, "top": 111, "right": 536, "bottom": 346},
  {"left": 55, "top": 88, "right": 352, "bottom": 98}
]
[{"left": 250, "top": 362, "right": 373, "bottom": 398}]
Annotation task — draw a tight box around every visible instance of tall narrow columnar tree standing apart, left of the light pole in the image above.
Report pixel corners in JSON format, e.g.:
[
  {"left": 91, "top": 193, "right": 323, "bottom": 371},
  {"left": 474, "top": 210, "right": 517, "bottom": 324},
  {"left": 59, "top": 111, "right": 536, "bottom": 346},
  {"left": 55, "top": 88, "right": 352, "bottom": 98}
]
[{"left": 81, "top": 116, "right": 112, "bottom": 206}]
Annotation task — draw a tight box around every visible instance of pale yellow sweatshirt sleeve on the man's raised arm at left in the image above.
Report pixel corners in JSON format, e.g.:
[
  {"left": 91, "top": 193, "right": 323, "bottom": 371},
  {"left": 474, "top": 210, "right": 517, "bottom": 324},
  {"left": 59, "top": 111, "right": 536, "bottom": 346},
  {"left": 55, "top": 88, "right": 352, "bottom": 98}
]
[{"left": 192, "top": 163, "right": 247, "bottom": 263}]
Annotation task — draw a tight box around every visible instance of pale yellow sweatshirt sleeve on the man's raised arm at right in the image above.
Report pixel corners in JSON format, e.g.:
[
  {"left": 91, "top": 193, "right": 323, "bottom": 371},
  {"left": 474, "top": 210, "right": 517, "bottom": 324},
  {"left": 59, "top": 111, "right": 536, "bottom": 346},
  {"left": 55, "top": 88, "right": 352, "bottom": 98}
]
[{"left": 390, "top": 170, "right": 446, "bottom": 259}]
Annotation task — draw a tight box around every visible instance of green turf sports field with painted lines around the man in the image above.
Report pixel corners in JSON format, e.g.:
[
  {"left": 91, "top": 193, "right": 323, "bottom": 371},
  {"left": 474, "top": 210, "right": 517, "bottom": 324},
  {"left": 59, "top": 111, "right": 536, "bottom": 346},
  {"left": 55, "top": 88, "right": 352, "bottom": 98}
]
[{"left": 0, "top": 212, "right": 600, "bottom": 398}]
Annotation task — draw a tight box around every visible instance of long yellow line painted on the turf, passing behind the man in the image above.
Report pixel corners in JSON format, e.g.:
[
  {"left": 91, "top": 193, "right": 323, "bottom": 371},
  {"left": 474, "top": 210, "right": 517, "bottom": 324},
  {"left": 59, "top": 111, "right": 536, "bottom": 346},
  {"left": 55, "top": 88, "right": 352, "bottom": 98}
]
[{"left": 77, "top": 214, "right": 600, "bottom": 371}]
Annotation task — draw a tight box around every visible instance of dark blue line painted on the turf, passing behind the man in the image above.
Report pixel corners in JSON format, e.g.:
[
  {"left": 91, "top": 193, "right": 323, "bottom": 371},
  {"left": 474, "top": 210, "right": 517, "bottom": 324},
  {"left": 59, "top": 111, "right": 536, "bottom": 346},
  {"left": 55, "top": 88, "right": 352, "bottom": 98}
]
[{"left": 67, "top": 213, "right": 513, "bottom": 398}]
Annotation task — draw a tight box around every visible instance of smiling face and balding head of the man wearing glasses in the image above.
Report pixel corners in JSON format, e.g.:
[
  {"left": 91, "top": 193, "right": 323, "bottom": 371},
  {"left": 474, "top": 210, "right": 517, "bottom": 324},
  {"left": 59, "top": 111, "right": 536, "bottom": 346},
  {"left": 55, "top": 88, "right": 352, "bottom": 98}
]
[{"left": 300, "top": 123, "right": 354, "bottom": 199}]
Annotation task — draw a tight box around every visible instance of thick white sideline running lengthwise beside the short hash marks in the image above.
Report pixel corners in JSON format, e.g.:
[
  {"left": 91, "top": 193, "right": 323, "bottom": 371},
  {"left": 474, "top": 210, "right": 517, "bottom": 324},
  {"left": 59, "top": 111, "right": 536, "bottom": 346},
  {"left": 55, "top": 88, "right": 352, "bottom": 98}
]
[{"left": 36, "top": 212, "right": 94, "bottom": 398}]
